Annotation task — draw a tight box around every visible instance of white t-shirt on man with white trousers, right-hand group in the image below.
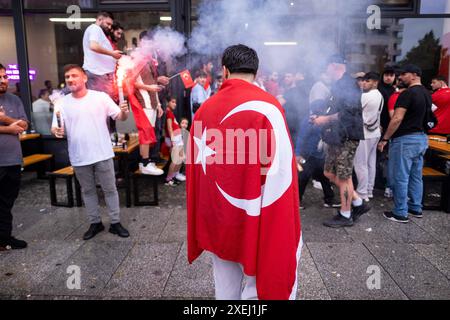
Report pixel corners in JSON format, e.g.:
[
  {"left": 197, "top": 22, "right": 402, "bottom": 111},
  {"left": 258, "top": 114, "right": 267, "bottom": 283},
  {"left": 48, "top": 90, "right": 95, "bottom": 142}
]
[{"left": 361, "top": 89, "right": 383, "bottom": 139}]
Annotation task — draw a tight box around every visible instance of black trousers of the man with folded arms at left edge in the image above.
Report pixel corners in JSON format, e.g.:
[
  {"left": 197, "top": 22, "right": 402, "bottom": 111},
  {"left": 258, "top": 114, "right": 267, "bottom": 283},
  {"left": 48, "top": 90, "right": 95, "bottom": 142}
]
[{"left": 0, "top": 166, "right": 21, "bottom": 239}]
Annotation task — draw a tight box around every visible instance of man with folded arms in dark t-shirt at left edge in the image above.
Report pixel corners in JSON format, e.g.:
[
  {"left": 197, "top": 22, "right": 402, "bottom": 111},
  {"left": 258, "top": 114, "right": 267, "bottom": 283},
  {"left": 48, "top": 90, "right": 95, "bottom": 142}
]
[{"left": 0, "top": 64, "right": 28, "bottom": 251}]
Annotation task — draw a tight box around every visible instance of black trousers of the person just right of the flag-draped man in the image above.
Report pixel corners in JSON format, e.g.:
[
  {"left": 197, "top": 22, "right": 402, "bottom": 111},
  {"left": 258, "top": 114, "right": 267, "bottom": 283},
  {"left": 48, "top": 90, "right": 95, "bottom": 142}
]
[{"left": 298, "top": 157, "right": 334, "bottom": 203}]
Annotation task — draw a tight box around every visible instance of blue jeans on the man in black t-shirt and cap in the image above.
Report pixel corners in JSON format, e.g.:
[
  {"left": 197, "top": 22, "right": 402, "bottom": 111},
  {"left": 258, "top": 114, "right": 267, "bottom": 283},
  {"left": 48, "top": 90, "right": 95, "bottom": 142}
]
[{"left": 389, "top": 133, "right": 428, "bottom": 217}]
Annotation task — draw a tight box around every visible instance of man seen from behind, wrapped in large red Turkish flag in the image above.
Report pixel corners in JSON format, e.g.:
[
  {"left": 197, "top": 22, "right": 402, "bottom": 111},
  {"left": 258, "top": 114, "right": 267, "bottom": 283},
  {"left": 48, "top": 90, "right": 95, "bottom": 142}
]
[{"left": 186, "top": 45, "right": 302, "bottom": 300}]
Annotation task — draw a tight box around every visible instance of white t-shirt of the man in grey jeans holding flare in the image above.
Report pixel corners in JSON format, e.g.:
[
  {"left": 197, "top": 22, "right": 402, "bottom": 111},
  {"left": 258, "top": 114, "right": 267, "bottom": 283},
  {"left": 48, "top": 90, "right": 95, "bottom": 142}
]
[{"left": 52, "top": 90, "right": 120, "bottom": 166}]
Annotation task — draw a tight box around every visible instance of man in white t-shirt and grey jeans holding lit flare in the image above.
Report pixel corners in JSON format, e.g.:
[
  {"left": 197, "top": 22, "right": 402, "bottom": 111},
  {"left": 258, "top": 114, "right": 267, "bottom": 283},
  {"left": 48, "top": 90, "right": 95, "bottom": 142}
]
[{"left": 52, "top": 64, "right": 129, "bottom": 240}]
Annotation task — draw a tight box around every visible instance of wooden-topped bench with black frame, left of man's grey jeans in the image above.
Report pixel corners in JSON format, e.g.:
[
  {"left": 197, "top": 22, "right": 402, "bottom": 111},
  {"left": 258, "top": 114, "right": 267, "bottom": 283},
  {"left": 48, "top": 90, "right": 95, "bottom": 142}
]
[{"left": 48, "top": 167, "right": 81, "bottom": 208}]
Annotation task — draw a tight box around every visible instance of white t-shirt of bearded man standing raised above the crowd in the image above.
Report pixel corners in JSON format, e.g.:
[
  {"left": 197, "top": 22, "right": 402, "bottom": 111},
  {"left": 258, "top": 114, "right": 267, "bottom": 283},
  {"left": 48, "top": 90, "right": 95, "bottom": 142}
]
[{"left": 83, "top": 23, "right": 116, "bottom": 75}]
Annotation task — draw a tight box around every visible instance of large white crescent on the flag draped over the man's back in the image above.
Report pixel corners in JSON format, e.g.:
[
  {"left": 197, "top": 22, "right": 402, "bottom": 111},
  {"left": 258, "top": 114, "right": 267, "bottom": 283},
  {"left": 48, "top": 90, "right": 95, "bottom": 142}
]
[{"left": 216, "top": 101, "right": 292, "bottom": 216}]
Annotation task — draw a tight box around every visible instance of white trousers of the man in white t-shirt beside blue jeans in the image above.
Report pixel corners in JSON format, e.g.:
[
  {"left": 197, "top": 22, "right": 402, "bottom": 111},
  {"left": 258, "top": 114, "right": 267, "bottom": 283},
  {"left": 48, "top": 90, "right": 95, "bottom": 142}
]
[{"left": 354, "top": 138, "right": 380, "bottom": 198}]
